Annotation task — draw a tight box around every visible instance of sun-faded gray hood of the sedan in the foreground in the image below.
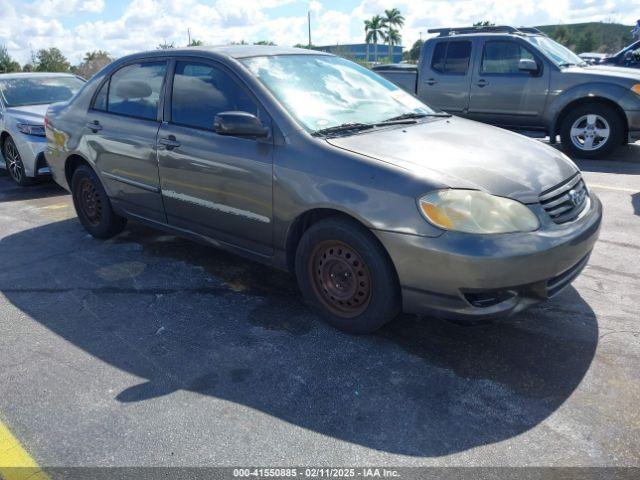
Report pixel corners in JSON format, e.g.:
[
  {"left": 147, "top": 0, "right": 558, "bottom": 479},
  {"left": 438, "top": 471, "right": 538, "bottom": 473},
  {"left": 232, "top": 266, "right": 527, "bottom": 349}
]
[{"left": 327, "top": 117, "right": 579, "bottom": 203}]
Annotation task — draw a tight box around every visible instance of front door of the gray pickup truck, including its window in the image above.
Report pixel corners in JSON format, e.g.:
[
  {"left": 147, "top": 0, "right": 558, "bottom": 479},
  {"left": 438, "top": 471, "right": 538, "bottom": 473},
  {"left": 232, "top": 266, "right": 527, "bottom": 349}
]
[{"left": 469, "top": 38, "right": 550, "bottom": 129}]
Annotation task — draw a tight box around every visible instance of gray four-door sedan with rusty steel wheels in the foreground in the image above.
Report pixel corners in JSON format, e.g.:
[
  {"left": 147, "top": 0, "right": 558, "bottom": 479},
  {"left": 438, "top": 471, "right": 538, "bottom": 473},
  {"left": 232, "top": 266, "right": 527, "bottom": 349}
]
[{"left": 46, "top": 46, "right": 602, "bottom": 333}]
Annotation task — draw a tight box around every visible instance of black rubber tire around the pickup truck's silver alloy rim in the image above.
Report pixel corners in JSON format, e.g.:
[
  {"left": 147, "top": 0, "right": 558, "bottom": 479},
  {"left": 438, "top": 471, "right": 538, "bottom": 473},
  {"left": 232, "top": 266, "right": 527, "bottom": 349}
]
[{"left": 560, "top": 103, "right": 625, "bottom": 159}]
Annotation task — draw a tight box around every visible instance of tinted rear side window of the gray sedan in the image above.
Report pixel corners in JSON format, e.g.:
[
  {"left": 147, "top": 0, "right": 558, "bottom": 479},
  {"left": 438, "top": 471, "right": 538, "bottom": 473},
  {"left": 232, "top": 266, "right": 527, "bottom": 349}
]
[{"left": 100, "top": 62, "right": 167, "bottom": 120}]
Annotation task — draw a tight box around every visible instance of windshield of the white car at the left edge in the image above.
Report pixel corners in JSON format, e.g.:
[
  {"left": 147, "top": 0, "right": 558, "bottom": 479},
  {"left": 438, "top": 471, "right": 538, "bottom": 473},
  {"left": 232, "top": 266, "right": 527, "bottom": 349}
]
[{"left": 0, "top": 77, "right": 84, "bottom": 107}]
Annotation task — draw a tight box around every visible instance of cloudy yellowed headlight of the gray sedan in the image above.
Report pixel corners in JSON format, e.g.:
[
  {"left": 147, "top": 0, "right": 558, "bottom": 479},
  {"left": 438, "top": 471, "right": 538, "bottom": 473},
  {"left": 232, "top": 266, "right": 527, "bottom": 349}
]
[{"left": 418, "top": 190, "right": 540, "bottom": 234}]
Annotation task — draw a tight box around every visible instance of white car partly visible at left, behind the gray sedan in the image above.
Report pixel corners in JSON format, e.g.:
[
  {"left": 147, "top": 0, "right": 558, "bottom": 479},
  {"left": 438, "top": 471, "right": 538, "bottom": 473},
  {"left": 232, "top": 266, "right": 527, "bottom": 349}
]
[{"left": 0, "top": 73, "right": 84, "bottom": 186}]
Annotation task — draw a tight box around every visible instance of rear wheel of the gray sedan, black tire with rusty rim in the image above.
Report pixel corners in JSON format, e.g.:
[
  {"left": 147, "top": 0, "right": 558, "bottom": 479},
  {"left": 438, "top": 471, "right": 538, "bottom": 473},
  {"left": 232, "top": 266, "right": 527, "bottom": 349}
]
[{"left": 71, "top": 165, "right": 127, "bottom": 239}]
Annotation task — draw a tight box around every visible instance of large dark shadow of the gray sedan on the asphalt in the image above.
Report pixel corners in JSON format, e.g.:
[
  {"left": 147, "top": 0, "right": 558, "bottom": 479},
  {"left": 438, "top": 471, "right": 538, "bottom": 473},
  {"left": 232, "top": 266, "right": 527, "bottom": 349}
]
[{"left": 0, "top": 219, "right": 598, "bottom": 456}]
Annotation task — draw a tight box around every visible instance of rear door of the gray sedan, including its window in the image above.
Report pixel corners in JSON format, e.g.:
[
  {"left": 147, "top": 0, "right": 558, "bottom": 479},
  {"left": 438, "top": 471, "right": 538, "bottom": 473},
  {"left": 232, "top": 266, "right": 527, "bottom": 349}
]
[{"left": 84, "top": 60, "right": 168, "bottom": 222}]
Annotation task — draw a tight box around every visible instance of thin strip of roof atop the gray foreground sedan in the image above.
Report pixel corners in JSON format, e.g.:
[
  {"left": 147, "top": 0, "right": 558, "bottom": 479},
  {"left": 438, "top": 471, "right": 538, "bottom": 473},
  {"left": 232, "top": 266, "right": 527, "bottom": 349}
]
[{"left": 120, "top": 45, "right": 332, "bottom": 60}]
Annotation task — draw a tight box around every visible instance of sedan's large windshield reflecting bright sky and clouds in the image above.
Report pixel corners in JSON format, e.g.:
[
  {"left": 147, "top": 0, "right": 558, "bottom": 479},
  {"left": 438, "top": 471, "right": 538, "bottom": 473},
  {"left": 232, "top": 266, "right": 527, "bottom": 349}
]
[{"left": 242, "top": 55, "right": 435, "bottom": 132}]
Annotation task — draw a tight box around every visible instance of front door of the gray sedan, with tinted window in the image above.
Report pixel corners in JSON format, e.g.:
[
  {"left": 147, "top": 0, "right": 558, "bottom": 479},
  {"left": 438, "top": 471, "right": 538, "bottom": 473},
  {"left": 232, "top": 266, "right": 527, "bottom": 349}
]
[{"left": 158, "top": 60, "right": 273, "bottom": 255}]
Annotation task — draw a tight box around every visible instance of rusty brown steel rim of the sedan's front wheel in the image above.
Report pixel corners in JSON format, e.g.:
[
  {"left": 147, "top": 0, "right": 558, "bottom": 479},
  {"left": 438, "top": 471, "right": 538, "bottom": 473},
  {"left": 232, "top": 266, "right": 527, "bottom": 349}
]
[{"left": 309, "top": 240, "right": 372, "bottom": 318}]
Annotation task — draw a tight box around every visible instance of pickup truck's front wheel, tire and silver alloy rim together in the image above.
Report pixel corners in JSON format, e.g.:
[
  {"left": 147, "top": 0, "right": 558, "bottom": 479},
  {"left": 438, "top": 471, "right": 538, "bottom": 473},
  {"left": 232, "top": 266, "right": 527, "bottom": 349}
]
[{"left": 560, "top": 103, "right": 624, "bottom": 158}]
